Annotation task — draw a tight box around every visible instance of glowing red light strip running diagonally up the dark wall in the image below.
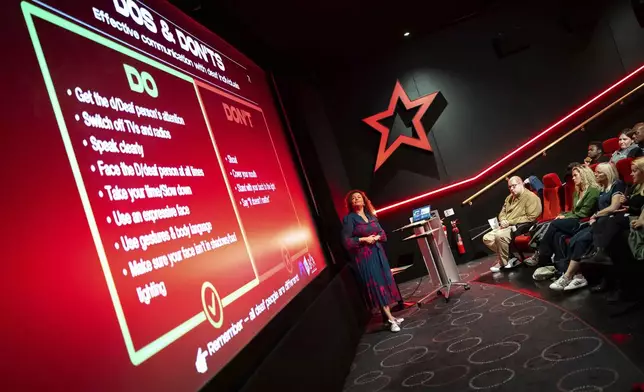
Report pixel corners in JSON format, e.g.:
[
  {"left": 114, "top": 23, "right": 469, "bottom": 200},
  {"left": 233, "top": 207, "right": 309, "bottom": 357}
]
[{"left": 376, "top": 65, "right": 644, "bottom": 213}]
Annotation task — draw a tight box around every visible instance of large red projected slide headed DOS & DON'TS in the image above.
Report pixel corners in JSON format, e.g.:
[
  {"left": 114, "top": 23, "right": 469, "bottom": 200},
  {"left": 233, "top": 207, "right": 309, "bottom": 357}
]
[{"left": 0, "top": 0, "right": 325, "bottom": 391}]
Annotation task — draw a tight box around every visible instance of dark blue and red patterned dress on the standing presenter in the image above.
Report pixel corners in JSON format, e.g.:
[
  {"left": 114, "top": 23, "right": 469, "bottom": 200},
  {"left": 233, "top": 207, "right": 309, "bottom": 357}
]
[{"left": 342, "top": 212, "right": 402, "bottom": 308}]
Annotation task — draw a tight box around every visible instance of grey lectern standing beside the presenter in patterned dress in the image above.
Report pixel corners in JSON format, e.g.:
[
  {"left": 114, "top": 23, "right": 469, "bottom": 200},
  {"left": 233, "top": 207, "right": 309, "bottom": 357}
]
[{"left": 394, "top": 211, "right": 470, "bottom": 307}]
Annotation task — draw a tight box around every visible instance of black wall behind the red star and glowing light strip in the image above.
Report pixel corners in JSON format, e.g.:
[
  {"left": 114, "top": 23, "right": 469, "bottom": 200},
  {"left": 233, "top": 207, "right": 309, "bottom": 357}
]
[{"left": 281, "top": 0, "right": 644, "bottom": 276}]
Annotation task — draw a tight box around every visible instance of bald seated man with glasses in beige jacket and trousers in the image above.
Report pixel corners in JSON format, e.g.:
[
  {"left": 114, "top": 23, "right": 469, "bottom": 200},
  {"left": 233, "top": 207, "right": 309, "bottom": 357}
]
[{"left": 483, "top": 176, "right": 541, "bottom": 272}]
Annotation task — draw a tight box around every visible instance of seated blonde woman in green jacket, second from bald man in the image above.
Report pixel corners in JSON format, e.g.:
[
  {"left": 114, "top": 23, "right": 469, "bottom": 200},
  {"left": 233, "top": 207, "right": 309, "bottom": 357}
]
[{"left": 535, "top": 165, "right": 599, "bottom": 274}]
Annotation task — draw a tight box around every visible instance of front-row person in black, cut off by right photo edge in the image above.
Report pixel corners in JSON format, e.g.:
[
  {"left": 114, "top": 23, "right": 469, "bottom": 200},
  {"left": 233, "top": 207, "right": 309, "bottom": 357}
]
[{"left": 583, "top": 157, "right": 644, "bottom": 264}]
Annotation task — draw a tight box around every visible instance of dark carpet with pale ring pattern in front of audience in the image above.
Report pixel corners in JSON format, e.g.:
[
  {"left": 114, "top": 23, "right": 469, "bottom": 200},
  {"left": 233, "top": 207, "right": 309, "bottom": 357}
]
[{"left": 344, "top": 282, "right": 644, "bottom": 392}]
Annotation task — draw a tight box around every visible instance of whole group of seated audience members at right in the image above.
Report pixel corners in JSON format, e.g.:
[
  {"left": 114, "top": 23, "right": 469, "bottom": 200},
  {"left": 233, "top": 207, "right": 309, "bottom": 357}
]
[{"left": 483, "top": 123, "right": 644, "bottom": 300}]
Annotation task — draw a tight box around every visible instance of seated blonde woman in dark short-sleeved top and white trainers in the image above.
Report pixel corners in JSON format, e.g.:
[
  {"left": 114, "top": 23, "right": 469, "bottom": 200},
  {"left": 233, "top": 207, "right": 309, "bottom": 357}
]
[{"left": 550, "top": 163, "right": 626, "bottom": 291}]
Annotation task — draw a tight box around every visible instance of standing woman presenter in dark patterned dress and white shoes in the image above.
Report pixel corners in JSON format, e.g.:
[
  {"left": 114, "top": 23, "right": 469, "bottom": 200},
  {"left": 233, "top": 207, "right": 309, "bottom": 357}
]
[{"left": 342, "top": 190, "right": 404, "bottom": 332}]
